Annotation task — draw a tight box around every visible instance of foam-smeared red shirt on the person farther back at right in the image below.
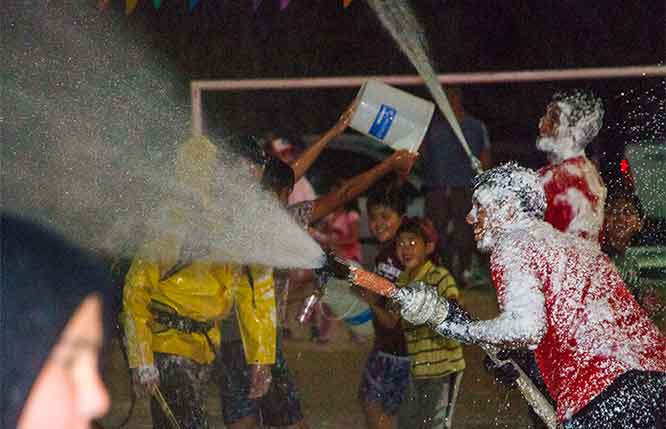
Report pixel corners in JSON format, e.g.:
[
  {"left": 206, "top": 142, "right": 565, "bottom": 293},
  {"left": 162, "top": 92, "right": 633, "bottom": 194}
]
[{"left": 539, "top": 155, "right": 606, "bottom": 241}]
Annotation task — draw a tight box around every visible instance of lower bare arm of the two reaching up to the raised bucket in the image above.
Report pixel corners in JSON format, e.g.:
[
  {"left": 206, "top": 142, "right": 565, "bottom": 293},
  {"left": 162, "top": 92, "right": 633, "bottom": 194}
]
[{"left": 310, "top": 150, "right": 417, "bottom": 223}]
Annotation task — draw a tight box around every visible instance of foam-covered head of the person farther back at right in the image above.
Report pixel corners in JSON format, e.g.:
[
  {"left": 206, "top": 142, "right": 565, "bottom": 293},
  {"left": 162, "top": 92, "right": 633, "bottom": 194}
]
[{"left": 537, "top": 90, "right": 604, "bottom": 161}]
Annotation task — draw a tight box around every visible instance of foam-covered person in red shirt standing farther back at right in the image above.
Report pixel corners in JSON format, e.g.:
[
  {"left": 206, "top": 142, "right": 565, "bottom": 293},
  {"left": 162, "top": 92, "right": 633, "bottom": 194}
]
[{"left": 536, "top": 91, "right": 606, "bottom": 241}]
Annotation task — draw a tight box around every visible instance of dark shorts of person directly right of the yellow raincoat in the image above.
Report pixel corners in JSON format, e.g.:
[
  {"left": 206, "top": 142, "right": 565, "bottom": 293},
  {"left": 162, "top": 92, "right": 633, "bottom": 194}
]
[{"left": 220, "top": 341, "right": 303, "bottom": 426}]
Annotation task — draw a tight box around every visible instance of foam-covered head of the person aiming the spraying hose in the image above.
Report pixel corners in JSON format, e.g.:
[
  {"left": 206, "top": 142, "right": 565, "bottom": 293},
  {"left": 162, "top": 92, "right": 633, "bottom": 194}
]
[{"left": 467, "top": 162, "right": 546, "bottom": 251}]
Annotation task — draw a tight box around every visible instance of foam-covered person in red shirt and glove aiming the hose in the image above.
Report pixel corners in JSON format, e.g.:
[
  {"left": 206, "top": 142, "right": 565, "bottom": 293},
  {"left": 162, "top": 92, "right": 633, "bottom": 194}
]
[{"left": 394, "top": 164, "right": 666, "bottom": 429}]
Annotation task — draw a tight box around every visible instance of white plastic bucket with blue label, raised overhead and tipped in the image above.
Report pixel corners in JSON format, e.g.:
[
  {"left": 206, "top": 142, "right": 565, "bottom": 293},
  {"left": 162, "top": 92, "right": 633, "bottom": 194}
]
[{"left": 349, "top": 80, "right": 435, "bottom": 152}]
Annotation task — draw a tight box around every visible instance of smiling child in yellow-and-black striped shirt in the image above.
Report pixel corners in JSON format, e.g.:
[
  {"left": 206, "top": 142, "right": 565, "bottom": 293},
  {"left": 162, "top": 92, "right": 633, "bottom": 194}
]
[{"left": 396, "top": 218, "right": 465, "bottom": 429}]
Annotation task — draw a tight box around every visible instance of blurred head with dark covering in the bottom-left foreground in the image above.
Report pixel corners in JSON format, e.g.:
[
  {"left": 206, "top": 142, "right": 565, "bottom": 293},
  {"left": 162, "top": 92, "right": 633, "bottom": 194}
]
[{"left": 0, "top": 213, "right": 110, "bottom": 429}]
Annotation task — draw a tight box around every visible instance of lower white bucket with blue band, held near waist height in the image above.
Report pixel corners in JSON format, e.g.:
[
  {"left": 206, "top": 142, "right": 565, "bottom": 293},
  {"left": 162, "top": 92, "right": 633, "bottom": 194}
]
[{"left": 321, "top": 278, "right": 375, "bottom": 338}]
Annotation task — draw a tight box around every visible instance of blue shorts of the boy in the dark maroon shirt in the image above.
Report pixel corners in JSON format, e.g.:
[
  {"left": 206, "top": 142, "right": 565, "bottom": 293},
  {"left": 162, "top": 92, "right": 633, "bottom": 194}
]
[{"left": 358, "top": 350, "right": 410, "bottom": 416}]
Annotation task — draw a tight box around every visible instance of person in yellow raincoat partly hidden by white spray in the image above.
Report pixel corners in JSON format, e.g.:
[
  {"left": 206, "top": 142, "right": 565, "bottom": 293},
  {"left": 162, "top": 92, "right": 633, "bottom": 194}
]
[{"left": 123, "top": 138, "right": 276, "bottom": 429}]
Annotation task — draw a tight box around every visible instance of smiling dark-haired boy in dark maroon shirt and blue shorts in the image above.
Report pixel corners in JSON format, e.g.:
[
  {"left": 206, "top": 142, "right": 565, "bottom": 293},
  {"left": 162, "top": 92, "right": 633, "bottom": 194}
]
[{"left": 356, "top": 175, "right": 410, "bottom": 429}]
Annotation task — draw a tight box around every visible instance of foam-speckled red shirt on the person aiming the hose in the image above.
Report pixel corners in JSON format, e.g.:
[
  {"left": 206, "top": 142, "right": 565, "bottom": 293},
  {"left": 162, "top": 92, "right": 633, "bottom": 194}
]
[{"left": 491, "top": 222, "right": 666, "bottom": 422}]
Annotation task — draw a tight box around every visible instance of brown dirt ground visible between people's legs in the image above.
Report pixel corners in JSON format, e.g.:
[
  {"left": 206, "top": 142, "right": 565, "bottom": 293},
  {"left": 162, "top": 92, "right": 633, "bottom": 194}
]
[{"left": 97, "top": 287, "right": 527, "bottom": 429}]
